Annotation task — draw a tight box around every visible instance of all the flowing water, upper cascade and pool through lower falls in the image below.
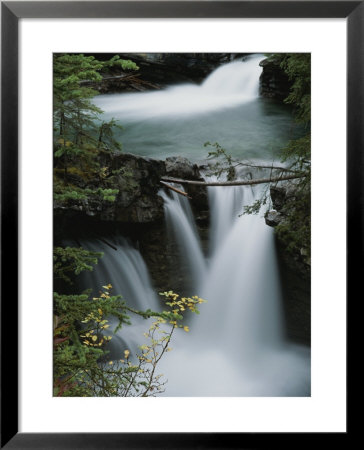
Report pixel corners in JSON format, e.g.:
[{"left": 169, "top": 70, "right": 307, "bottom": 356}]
[{"left": 77, "top": 56, "right": 310, "bottom": 396}]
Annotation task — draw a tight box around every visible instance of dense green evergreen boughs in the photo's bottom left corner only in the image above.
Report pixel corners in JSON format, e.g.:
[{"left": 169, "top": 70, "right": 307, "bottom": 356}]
[{"left": 53, "top": 286, "right": 129, "bottom": 396}]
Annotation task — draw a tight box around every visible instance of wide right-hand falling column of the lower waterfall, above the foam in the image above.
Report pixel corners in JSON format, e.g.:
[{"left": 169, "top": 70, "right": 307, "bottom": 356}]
[{"left": 196, "top": 181, "right": 282, "bottom": 355}]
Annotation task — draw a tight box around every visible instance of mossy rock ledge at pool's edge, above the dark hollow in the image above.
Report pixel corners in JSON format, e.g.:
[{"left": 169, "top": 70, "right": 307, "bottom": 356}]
[{"left": 54, "top": 152, "right": 208, "bottom": 224}]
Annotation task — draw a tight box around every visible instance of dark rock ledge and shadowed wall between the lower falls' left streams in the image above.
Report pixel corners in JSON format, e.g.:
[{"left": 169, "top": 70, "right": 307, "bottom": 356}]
[{"left": 54, "top": 152, "right": 208, "bottom": 295}]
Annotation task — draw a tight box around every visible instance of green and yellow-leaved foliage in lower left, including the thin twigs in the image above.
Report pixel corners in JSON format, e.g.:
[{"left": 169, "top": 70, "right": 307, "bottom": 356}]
[{"left": 53, "top": 247, "right": 204, "bottom": 397}]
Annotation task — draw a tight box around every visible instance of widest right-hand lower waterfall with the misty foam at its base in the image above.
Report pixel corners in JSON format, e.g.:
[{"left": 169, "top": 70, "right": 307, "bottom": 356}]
[{"left": 156, "top": 181, "right": 310, "bottom": 396}]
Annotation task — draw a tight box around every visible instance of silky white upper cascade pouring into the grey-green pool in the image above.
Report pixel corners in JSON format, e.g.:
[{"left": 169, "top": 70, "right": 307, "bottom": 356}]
[{"left": 94, "top": 55, "right": 262, "bottom": 121}]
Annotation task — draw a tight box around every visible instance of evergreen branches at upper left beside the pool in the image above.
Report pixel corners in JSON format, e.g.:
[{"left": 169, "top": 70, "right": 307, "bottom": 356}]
[{"left": 53, "top": 54, "right": 138, "bottom": 204}]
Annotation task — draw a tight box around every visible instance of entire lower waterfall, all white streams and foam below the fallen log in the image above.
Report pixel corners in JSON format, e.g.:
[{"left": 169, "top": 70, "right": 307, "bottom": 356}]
[{"left": 77, "top": 181, "right": 310, "bottom": 396}]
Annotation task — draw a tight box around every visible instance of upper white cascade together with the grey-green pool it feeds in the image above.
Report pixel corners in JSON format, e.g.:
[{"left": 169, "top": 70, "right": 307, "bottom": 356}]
[{"left": 94, "top": 55, "right": 299, "bottom": 161}]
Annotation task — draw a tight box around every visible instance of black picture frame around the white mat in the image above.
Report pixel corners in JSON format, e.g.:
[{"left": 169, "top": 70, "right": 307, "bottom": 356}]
[{"left": 1, "top": 1, "right": 358, "bottom": 449}]
